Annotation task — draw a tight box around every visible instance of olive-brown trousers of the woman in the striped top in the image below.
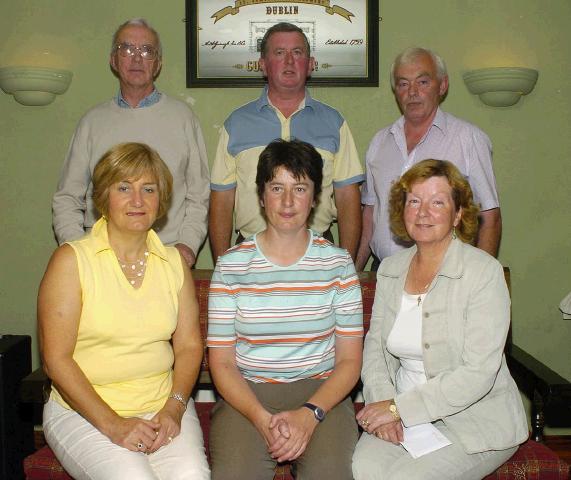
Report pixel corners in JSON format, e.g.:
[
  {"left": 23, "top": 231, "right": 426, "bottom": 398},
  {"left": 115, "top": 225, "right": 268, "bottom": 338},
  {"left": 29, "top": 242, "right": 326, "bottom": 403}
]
[{"left": 210, "top": 380, "right": 358, "bottom": 480}]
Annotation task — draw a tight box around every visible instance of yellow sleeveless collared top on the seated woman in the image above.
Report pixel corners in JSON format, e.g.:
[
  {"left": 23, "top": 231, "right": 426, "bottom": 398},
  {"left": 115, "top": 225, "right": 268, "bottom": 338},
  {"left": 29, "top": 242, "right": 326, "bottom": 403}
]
[{"left": 51, "top": 218, "right": 184, "bottom": 417}]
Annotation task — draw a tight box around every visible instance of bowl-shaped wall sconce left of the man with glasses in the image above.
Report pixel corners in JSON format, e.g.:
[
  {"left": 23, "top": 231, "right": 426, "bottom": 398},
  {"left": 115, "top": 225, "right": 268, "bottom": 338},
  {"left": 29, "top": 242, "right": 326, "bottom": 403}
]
[{"left": 0, "top": 66, "right": 73, "bottom": 106}]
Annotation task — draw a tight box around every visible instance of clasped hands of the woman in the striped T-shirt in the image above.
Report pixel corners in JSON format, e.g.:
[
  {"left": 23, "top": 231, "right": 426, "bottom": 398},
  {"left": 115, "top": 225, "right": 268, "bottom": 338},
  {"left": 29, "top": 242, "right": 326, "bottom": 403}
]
[{"left": 262, "top": 407, "right": 318, "bottom": 462}]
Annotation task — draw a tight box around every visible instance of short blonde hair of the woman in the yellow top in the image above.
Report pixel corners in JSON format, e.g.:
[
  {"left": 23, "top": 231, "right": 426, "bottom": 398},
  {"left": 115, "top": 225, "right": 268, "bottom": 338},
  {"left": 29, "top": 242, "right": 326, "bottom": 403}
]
[{"left": 92, "top": 142, "right": 172, "bottom": 218}]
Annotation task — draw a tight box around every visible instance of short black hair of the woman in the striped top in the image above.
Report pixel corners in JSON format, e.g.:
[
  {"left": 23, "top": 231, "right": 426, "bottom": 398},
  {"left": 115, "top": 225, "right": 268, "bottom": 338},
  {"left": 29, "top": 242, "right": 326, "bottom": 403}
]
[{"left": 256, "top": 139, "right": 323, "bottom": 201}]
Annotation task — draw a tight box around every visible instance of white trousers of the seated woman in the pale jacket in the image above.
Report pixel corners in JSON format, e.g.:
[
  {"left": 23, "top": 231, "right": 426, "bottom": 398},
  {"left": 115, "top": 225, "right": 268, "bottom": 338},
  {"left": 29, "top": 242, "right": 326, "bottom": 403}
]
[{"left": 353, "top": 421, "right": 518, "bottom": 480}]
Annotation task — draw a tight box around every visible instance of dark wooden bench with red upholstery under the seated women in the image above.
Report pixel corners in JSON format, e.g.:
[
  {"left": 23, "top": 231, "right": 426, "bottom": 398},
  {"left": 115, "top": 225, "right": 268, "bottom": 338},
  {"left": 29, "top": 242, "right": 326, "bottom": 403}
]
[{"left": 20, "top": 269, "right": 571, "bottom": 480}]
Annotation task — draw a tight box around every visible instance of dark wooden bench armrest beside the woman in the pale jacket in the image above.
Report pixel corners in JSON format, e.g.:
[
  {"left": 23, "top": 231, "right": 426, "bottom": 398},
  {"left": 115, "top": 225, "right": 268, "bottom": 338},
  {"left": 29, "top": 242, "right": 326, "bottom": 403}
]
[{"left": 506, "top": 345, "right": 571, "bottom": 442}]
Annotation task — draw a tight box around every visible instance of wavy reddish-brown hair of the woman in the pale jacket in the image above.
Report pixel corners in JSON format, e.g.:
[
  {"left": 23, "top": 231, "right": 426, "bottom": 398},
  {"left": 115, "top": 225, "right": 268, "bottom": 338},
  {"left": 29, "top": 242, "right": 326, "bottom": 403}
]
[{"left": 389, "top": 159, "right": 480, "bottom": 243}]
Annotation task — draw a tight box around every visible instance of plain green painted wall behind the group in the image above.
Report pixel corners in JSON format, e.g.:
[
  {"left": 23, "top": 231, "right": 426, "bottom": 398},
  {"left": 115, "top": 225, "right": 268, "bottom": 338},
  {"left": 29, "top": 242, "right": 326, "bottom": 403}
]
[{"left": 0, "top": 0, "right": 571, "bottom": 390}]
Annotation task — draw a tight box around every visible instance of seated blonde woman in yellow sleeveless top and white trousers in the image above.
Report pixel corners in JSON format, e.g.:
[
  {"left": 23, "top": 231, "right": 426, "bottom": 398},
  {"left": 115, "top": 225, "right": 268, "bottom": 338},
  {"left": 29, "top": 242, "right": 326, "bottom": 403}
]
[{"left": 38, "top": 143, "right": 210, "bottom": 480}]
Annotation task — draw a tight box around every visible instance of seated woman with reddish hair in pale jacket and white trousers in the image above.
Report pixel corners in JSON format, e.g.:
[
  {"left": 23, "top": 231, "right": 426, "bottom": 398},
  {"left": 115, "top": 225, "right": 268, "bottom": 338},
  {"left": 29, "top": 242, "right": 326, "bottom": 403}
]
[{"left": 353, "top": 160, "right": 528, "bottom": 480}]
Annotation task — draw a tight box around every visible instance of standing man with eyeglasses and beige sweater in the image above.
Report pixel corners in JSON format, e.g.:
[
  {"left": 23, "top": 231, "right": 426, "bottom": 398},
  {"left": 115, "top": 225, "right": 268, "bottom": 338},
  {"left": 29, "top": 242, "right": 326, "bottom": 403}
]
[{"left": 52, "top": 19, "right": 210, "bottom": 266}]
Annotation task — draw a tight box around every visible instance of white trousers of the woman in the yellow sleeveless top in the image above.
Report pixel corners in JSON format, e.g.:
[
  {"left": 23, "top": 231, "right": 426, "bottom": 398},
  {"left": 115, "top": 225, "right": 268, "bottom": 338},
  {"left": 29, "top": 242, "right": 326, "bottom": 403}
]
[{"left": 43, "top": 400, "right": 210, "bottom": 480}]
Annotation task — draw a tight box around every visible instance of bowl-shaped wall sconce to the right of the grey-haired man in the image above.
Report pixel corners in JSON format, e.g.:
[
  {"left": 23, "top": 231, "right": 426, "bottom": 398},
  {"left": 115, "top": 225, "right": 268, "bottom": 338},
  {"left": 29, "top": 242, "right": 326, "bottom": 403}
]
[{"left": 463, "top": 67, "right": 539, "bottom": 107}]
